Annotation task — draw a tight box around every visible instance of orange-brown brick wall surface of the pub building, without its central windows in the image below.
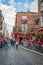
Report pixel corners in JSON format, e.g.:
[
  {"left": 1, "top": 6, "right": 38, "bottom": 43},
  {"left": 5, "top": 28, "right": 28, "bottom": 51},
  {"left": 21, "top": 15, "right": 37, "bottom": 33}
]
[{"left": 15, "top": 12, "right": 38, "bottom": 30}]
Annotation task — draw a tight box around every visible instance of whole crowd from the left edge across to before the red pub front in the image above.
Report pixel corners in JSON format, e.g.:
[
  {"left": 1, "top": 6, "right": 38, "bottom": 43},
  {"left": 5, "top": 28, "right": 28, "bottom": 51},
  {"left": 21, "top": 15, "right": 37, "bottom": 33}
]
[{"left": 0, "top": 37, "right": 41, "bottom": 49}]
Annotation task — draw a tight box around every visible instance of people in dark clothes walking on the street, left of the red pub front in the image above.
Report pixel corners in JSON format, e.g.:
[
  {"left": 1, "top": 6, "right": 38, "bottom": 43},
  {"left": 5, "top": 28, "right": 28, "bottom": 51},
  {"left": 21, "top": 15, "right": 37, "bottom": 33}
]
[{"left": 0, "top": 38, "right": 23, "bottom": 49}]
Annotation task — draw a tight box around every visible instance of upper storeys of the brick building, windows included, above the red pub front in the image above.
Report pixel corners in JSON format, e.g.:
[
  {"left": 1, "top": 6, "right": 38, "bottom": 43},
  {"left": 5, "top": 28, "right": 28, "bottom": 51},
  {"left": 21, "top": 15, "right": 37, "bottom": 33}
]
[{"left": 15, "top": 12, "right": 38, "bottom": 32}]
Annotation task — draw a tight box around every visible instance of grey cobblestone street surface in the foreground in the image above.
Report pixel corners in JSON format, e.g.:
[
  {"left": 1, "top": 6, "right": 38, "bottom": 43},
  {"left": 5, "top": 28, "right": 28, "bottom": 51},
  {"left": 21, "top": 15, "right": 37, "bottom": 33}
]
[{"left": 0, "top": 47, "right": 43, "bottom": 65}]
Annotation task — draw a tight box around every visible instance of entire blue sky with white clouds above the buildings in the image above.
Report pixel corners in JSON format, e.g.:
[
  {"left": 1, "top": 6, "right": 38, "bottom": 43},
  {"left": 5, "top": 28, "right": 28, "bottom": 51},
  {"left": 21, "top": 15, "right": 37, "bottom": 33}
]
[{"left": 0, "top": 0, "right": 38, "bottom": 32}]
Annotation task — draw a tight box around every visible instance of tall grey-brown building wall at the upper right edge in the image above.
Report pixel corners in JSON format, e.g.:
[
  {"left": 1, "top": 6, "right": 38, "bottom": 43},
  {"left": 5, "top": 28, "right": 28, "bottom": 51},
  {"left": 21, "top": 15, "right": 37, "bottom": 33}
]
[{"left": 38, "top": 0, "right": 43, "bottom": 27}]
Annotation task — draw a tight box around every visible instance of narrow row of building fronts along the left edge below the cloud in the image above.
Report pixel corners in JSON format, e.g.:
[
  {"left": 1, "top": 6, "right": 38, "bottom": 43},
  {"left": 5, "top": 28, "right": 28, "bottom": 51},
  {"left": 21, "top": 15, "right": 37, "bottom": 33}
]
[{"left": 0, "top": 10, "right": 6, "bottom": 36}]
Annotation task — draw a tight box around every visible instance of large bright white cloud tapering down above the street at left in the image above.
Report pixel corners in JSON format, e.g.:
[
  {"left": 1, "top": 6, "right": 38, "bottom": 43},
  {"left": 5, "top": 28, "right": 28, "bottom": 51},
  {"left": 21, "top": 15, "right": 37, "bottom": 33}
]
[{"left": 0, "top": 3, "right": 16, "bottom": 32}]
